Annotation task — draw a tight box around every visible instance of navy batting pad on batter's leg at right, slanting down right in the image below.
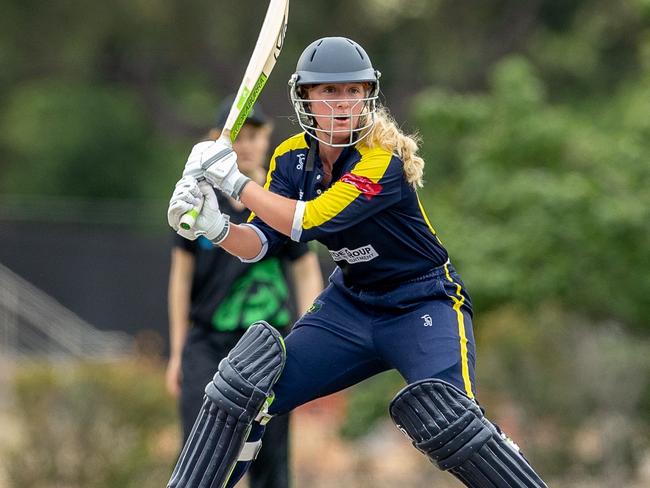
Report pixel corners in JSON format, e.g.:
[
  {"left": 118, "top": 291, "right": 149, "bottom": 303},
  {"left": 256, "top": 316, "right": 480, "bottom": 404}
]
[{"left": 389, "top": 379, "right": 547, "bottom": 488}]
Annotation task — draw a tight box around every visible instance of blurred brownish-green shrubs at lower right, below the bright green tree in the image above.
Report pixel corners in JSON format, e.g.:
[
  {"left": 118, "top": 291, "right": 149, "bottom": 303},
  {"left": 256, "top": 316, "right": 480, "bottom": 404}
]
[{"left": 477, "top": 306, "right": 650, "bottom": 478}]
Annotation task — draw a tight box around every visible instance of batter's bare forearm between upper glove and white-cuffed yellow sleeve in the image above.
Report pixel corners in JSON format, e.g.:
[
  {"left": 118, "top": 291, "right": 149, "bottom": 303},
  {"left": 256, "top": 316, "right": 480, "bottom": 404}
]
[{"left": 241, "top": 182, "right": 296, "bottom": 236}]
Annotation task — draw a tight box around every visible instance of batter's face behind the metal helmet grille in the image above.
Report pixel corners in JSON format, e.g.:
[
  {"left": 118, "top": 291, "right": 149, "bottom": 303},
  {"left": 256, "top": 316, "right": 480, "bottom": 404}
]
[{"left": 307, "top": 83, "right": 368, "bottom": 143}]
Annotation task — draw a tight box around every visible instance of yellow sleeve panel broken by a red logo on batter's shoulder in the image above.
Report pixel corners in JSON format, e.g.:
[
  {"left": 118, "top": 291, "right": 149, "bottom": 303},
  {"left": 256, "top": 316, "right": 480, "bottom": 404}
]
[{"left": 302, "top": 146, "right": 392, "bottom": 230}]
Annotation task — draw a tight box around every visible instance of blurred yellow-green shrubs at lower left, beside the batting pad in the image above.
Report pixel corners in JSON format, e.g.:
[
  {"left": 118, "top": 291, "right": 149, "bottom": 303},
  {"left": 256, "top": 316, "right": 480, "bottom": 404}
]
[{"left": 3, "top": 359, "right": 178, "bottom": 488}]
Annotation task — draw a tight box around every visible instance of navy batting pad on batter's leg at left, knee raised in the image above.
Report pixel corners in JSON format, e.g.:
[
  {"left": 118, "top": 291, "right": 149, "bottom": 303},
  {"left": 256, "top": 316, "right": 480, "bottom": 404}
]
[{"left": 167, "top": 322, "right": 286, "bottom": 488}]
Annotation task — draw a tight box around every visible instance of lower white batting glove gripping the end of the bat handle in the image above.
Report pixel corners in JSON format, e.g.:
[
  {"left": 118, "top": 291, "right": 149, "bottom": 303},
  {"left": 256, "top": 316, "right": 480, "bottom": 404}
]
[{"left": 167, "top": 176, "right": 230, "bottom": 244}]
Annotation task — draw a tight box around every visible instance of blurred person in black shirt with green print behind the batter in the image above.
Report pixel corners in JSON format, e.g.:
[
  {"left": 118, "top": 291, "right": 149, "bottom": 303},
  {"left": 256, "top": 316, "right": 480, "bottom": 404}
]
[{"left": 166, "top": 97, "right": 322, "bottom": 488}]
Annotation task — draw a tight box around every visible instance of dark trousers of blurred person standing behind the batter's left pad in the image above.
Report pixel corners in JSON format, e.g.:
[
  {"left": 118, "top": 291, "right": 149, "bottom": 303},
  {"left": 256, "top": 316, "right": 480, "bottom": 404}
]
[{"left": 180, "top": 327, "right": 289, "bottom": 488}]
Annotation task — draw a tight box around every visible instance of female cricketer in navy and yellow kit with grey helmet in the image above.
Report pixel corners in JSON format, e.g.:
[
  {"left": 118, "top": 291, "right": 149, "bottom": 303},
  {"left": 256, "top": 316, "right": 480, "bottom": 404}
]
[{"left": 168, "top": 37, "right": 546, "bottom": 488}]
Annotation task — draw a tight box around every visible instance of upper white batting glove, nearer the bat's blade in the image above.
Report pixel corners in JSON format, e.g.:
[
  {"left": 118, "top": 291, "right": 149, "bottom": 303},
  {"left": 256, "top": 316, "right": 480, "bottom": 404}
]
[{"left": 183, "top": 139, "right": 250, "bottom": 200}]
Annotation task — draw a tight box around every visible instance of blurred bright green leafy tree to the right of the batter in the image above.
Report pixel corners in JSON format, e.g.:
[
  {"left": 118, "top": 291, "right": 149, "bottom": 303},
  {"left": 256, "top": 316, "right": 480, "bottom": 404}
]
[{"left": 415, "top": 58, "right": 650, "bottom": 333}]
